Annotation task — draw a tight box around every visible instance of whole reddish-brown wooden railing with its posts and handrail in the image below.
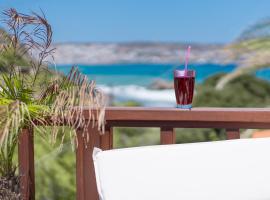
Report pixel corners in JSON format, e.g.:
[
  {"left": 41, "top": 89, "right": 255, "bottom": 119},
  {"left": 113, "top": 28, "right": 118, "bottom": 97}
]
[{"left": 18, "top": 107, "right": 270, "bottom": 200}]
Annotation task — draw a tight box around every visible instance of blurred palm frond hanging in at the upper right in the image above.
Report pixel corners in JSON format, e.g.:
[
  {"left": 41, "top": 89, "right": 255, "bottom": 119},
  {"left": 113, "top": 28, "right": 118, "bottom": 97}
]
[{"left": 216, "top": 18, "right": 270, "bottom": 90}]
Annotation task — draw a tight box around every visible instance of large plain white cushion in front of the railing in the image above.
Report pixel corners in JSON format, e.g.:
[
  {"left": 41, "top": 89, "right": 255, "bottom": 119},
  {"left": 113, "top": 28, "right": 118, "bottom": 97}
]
[{"left": 93, "top": 138, "right": 270, "bottom": 200}]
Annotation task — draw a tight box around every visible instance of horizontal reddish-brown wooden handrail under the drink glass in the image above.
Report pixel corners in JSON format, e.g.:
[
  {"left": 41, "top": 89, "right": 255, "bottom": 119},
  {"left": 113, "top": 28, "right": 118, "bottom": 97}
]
[{"left": 106, "top": 107, "right": 270, "bottom": 123}]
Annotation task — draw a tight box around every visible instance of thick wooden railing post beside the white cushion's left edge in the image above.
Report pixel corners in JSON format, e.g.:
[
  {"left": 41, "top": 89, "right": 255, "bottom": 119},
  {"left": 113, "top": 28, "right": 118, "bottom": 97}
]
[{"left": 76, "top": 125, "right": 100, "bottom": 200}]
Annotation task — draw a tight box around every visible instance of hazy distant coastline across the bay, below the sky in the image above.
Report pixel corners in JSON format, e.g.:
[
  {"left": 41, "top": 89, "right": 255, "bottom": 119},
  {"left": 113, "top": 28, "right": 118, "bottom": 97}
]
[{"left": 53, "top": 42, "right": 235, "bottom": 65}]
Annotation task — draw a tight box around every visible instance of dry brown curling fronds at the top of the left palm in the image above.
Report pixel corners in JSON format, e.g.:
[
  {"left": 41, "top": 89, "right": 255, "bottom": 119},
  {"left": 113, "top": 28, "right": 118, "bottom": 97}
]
[{"left": 2, "top": 8, "right": 54, "bottom": 85}]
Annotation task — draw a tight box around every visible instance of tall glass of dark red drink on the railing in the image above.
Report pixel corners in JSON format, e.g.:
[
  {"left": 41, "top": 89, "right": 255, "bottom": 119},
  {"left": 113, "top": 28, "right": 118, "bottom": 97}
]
[{"left": 174, "top": 70, "right": 195, "bottom": 109}]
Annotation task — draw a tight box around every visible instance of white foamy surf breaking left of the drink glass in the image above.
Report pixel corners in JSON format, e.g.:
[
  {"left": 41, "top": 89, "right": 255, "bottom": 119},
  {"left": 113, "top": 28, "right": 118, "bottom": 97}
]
[{"left": 99, "top": 85, "right": 175, "bottom": 107}]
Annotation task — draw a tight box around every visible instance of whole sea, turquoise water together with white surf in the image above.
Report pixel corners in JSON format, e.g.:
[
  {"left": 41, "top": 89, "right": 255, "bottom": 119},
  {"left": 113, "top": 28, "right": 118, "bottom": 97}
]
[{"left": 53, "top": 63, "right": 270, "bottom": 107}]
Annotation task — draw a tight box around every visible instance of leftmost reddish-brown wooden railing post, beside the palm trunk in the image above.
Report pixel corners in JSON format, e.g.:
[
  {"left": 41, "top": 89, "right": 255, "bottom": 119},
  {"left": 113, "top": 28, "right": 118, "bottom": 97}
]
[{"left": 18, "top": 128, "right": 35, "bottom": 200}]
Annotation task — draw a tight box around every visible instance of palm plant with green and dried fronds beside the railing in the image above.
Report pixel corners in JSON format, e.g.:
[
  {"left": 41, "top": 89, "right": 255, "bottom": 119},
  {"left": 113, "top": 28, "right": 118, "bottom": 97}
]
[{"left": 0, "top": 9, "right": 105, "bottom": 198}]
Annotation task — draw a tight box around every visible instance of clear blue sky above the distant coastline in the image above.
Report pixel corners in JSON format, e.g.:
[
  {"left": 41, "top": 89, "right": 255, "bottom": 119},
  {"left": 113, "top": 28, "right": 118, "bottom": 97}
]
[{"left": 0, "top": 0, "right": 270, "bottom": 43}]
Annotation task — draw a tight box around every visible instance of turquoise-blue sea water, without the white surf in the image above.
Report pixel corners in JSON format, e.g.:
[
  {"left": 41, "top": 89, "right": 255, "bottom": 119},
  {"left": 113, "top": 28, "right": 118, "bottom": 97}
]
[{"left": 53, "top": 64, "right": 270, "bottom": 86}]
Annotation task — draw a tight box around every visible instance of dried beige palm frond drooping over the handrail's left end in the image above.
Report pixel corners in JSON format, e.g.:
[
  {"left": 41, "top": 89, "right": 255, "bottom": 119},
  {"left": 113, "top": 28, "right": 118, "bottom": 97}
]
[{"left": 45, "top": 67, "right": 105, "bottom": 148}]
